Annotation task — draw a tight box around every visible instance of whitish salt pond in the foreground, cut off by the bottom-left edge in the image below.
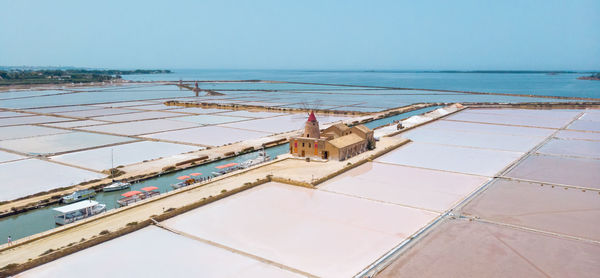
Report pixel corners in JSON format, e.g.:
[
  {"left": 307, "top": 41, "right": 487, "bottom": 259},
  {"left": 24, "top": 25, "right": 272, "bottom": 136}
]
[{"left": 15, "top": 226, "right": 304, "bottom": 278}]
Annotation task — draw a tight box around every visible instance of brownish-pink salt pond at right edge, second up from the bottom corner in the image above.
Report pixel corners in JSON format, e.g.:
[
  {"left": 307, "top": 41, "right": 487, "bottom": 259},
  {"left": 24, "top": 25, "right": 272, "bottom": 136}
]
[{"left": 462, "top": 179, "right": 600, "bottom": 240}]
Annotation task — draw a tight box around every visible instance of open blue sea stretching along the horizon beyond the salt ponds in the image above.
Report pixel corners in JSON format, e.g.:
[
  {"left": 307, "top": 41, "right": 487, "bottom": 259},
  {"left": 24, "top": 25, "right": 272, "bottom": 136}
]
[{"left": 124, "top": 70, "right": 600, "bottom": 98}]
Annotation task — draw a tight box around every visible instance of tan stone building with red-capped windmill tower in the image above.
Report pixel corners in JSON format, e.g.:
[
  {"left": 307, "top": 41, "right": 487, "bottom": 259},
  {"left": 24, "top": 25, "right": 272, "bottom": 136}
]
[{"left": 290, "top": 112, "right": 375, "bottom": 160}]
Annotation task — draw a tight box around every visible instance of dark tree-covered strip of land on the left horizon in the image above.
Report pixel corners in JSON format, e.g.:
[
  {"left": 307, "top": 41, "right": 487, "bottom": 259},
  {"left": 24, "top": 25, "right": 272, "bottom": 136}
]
[{"left": 0, "top": 69, "right": 171, "bottom": 86}]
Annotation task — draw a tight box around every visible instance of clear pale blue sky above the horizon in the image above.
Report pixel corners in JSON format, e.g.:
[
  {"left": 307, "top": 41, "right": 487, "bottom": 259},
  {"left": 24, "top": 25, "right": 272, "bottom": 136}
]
[{"left": 0, "top": 0, "right": 600, "bottom": 70}]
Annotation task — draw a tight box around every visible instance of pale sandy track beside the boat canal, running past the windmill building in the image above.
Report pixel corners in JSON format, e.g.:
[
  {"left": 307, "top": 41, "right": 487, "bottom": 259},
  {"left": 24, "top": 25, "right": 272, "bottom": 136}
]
[{"left": 0, "top": 138, "right": 406, "bottom": 267}]
